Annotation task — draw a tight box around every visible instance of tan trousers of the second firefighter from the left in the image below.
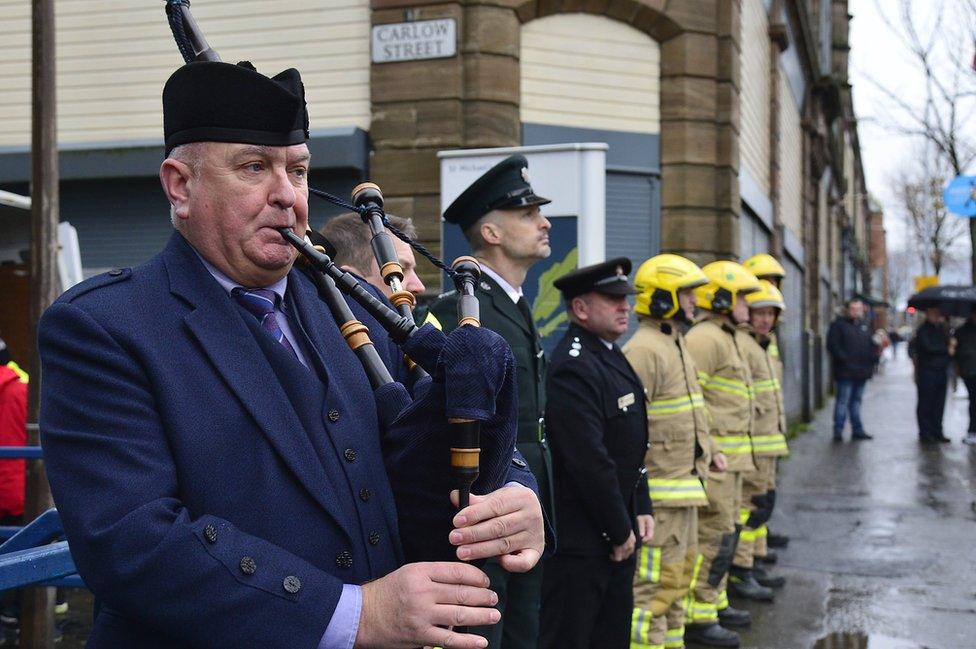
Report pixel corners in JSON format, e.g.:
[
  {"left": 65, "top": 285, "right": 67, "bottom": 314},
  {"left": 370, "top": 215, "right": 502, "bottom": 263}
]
[{"left": 685, "top": 472, "right": 742, "bottom": 624}]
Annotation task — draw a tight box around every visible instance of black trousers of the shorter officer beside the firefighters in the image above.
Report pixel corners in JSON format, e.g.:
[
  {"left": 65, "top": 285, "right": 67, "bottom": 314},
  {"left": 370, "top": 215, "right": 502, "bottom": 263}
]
[{"left": 539, "top": 554, "right": 636, "bottom": 649}]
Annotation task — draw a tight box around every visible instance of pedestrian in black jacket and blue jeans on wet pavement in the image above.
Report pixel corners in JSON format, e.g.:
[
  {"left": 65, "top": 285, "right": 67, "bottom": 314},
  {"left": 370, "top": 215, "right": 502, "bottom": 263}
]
[{"left": 827, "top": 298, "right": 879, "bottom": 442}]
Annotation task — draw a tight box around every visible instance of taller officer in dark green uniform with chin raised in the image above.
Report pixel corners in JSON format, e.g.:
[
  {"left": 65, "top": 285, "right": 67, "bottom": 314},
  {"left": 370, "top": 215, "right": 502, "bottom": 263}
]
[{"left": 430, "top": 155, "right": 553, "bottom": 649}]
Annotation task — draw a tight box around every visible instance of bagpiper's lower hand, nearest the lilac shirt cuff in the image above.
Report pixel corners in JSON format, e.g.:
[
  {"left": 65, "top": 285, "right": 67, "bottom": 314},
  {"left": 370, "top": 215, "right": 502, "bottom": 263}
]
[{"left": 353, "top": 562, "right": 501, "bottom": 649}]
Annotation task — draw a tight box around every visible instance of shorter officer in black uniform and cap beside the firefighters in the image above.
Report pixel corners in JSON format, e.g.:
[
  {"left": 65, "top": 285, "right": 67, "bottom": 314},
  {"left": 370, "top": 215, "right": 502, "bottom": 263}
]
[{"left": 539, "top": 257, "right": 654, "bottom": 649}]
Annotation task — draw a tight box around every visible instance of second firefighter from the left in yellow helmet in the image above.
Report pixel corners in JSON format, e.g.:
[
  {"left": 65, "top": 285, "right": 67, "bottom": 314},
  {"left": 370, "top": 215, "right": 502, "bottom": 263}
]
[{"left": 685, "top": 261, "right": 760, "bottom": 647}]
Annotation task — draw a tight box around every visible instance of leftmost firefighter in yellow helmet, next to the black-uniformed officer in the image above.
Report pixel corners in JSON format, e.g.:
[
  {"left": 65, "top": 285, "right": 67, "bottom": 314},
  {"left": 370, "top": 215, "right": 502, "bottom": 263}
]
[{"left": 624, "top": 254, "right": 725, "bottom": 649}]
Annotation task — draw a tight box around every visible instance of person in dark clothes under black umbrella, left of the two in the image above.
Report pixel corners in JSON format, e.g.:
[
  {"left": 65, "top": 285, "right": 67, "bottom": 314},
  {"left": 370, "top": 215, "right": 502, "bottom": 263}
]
[{"left": 908, "top": 307, "right": 955, "bottom": 444}]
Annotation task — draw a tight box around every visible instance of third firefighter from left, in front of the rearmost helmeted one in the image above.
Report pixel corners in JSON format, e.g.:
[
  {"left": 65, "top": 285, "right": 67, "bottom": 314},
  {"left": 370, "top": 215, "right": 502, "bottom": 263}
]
[{"left": 729, "top": 280, "right": 788, "bottom": 599}]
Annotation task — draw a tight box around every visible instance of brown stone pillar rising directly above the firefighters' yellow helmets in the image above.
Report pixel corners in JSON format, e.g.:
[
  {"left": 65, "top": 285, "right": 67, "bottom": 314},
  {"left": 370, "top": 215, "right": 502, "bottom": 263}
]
[{"left": 661, "top": 0, "right": 741, "bottom": 263}]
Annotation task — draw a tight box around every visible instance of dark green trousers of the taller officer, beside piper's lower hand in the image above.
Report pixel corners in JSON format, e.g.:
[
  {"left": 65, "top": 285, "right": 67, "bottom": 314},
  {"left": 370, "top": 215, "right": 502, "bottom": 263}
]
[{"left": 470, "top": 561, "right": 549, "bottom": 649}]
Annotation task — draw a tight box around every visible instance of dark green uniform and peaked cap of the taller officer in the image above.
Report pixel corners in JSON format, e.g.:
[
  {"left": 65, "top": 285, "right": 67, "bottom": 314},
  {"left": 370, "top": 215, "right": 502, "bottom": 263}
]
[{"left": 430, "top": 155, "right": 553, "bottom": 649}]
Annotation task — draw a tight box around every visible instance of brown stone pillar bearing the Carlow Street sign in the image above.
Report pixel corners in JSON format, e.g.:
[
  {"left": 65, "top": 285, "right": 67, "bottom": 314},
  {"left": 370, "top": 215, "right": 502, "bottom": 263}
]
[{"left": 370, "top": 0, "right": 521, "bottom": 290}]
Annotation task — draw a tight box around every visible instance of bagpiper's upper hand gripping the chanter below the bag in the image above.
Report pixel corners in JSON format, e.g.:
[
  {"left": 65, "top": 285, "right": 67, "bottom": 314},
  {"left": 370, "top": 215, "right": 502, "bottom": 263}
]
[{"left": 450, "top": 485, "right": 546, "bottom": 572}]
